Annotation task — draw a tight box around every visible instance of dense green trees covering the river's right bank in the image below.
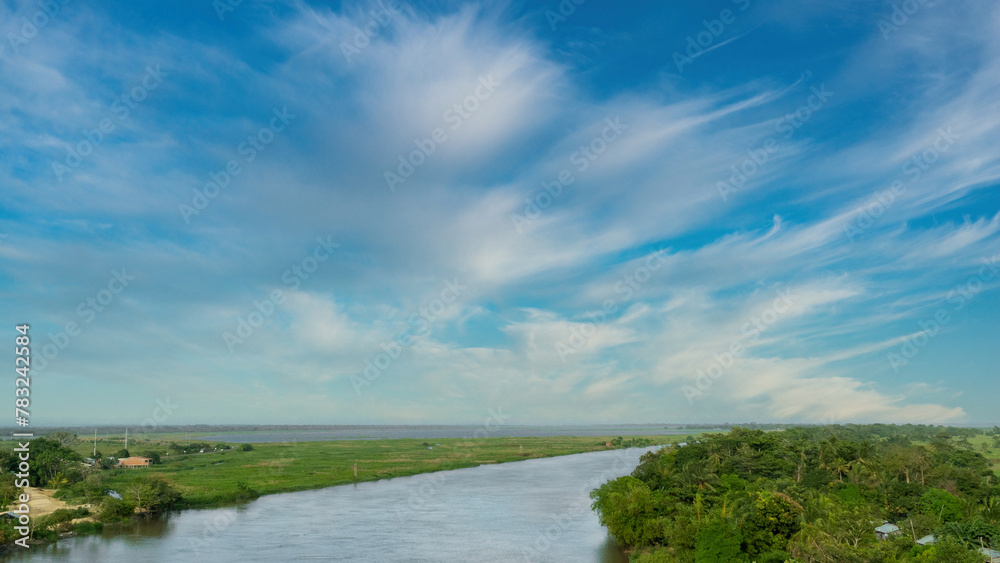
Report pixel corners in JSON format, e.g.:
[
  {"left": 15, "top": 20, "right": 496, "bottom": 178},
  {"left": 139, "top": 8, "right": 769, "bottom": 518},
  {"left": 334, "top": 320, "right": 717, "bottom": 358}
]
[{"left": 591, "top": 425, "right": 1000, "bottom": 563}]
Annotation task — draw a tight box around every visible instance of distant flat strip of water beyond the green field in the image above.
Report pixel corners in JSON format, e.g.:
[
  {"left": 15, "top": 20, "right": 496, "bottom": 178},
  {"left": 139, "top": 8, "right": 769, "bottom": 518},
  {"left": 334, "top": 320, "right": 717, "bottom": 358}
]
[{"left": 191, "top": 425, "right": 692, "bottom": 444}]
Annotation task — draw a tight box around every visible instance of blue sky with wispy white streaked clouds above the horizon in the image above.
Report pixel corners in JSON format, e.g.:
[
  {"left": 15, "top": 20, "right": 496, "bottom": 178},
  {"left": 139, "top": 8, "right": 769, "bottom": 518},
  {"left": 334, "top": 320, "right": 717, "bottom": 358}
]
[{"left": 0, "top": 0, "right": 1000, "bottom": 428}]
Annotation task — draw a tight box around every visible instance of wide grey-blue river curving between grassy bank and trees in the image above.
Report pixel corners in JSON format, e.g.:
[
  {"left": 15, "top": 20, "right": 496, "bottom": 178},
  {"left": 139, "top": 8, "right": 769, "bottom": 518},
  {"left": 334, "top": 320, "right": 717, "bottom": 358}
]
[{"left": 5, "top": 448, "right": 649, "bottom": 563}]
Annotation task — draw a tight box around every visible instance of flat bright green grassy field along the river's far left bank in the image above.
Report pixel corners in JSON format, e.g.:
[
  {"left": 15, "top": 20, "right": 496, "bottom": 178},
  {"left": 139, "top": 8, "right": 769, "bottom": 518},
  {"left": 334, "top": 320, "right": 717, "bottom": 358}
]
[{"left": 56, "top": 435, "right": 685, "bottom": 507}]
